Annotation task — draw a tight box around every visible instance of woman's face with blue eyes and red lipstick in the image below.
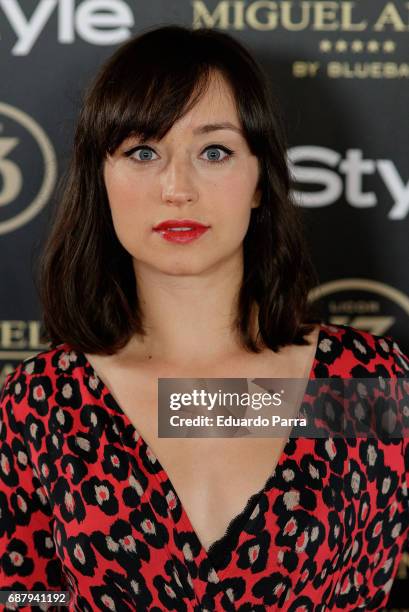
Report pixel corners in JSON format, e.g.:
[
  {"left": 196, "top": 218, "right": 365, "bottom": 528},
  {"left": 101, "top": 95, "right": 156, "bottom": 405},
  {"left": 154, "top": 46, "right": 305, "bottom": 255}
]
[{"left": 104, "top": 70, "right": 259, "bottom": 275}]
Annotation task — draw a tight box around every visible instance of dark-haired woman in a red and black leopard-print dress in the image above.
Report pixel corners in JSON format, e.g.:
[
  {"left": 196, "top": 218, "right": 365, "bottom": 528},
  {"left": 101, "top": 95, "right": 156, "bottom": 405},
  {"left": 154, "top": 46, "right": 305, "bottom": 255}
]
[{"left": 0, "top": 26, "right": 409, "bottom": 612}]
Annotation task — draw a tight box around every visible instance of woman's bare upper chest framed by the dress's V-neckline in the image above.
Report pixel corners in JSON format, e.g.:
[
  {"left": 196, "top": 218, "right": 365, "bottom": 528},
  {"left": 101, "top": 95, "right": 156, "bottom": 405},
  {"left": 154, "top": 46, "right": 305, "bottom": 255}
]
[{"left": 84, "top": 347, "right": 312, "bottom": 549}]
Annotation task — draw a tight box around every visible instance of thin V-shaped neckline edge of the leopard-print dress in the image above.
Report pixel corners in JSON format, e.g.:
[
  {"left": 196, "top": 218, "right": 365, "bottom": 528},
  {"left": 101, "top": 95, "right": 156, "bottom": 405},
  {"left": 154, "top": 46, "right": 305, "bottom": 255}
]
[{"left": 72, "top": 323, "right": 323, "bottom": 582}]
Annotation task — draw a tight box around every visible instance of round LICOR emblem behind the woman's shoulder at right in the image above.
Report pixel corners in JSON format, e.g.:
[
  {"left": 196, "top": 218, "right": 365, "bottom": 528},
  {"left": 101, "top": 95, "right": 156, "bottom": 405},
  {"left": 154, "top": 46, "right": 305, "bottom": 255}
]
[{"left": 309, "top": 278, "right": 409, "bottom": 342}]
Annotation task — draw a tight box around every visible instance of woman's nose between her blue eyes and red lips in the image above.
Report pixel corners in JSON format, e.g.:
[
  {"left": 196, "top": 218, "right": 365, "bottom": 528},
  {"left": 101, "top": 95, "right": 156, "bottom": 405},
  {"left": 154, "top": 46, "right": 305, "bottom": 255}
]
[{"left": 161, "top": 158, "right": 197, "bottom": 205}]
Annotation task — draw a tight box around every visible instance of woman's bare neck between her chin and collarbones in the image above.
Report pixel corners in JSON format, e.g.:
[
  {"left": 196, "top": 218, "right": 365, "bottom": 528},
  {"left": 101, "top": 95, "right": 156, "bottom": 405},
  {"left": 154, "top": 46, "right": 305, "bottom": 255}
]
[{"left": 127, "top": 262, "right": 256, "bottom": 367}]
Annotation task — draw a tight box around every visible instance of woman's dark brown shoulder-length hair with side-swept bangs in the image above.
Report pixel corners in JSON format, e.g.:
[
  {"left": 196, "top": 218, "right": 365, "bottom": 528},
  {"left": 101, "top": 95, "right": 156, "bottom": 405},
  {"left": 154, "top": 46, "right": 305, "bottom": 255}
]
[{"left": 36, "top": 25, "right": 319, "bottom": 354}]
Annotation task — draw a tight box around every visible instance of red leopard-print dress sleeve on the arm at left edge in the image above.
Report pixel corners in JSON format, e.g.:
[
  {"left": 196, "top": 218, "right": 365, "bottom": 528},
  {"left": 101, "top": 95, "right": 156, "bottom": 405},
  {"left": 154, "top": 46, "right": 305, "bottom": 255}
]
[{"left": 0, "top": 368, "right": 69, "bottom": 611}]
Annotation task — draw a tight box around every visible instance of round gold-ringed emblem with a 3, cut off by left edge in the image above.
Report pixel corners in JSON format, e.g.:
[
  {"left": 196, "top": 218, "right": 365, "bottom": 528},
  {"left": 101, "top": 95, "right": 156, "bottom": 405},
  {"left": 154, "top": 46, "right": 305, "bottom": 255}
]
[{"left": 0, "top": 102, "right": 57, "bottom": 235}]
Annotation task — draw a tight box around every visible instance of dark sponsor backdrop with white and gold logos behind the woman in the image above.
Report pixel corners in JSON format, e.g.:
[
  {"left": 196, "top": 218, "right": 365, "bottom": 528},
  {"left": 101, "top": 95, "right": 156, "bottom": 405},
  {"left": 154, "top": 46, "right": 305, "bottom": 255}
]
[{"left": 0, "top": 0, "right": 409, "bottom": 609}]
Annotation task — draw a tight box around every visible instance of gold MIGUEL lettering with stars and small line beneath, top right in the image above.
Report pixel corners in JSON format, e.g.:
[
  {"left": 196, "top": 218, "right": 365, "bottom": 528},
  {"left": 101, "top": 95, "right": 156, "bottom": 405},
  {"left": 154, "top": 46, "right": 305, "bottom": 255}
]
[{"left": 192, "top": 0, "right": 409, "bottom": 79}]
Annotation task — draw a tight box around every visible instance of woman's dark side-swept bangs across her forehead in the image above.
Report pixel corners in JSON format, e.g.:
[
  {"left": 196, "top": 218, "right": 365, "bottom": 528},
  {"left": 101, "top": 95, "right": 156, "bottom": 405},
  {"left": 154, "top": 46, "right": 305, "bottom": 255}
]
[{"left": 88, "top": 43, "right": 214, "bottom": 160}]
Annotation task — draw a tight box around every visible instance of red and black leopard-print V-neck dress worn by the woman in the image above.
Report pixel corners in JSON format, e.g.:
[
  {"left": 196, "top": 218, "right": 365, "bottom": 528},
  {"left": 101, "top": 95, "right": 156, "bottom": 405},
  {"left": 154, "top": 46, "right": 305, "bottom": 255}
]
[{"left": 0, "top": 324, "right": 409, "bottom": 612}]
